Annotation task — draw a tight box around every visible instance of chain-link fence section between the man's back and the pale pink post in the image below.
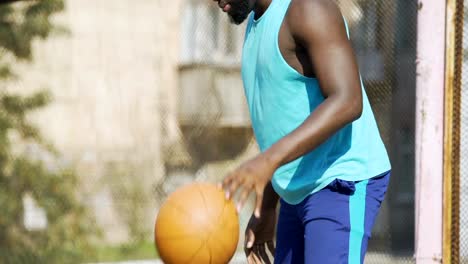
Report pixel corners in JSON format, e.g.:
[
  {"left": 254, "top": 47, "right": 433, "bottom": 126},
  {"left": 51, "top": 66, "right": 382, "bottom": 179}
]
[{"left": 338, "top": 0, "right": 417, "bottom": 263}]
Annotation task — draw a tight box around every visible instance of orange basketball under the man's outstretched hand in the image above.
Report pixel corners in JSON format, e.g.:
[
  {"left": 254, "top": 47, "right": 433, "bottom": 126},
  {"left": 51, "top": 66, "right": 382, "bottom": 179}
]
[{"left": 155, "top": 183, "right": 239, "bottom": 264}]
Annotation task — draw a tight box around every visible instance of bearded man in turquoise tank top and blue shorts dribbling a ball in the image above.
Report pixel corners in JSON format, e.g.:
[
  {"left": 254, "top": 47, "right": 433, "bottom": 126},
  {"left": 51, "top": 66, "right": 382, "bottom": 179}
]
[{"left": 216, "top": 0, "right": 390, "bottom": 264}]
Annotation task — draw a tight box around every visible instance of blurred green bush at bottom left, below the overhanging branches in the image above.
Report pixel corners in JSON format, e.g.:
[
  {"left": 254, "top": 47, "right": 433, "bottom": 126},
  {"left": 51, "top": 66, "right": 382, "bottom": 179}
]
[{"left": 0, "top": 157, "right": 95, "bottom": 263}]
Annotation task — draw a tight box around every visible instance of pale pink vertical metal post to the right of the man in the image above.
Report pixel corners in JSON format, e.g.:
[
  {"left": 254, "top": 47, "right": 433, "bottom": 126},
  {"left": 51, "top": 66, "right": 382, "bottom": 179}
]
[{"left": 415, "top": 0, "right": 446, "bottom": 264}]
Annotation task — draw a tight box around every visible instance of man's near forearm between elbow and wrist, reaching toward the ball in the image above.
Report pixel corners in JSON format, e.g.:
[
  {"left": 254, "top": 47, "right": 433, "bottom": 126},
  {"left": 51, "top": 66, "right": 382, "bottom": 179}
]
[{"left": 264, "top": 96, "right": 362, "bottom": 167}]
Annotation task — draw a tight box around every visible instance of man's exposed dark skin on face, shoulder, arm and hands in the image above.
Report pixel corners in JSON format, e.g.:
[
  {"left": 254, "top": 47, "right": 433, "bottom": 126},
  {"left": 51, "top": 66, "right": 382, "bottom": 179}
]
[{"left": 218, "top": 0, "right": 362, "bottom": 264}]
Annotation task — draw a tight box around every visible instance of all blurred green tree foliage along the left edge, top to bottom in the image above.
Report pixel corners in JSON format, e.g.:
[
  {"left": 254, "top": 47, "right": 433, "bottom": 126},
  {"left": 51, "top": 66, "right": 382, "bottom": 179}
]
[{"left": 0, "top": 0, "right": 95, "bottom": 263}]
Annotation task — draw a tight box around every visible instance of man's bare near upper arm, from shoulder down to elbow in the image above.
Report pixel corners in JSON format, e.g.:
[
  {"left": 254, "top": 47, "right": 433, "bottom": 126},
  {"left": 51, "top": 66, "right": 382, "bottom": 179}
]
[{"left": 287, "top": 0, "right": 362, "bottom": 101}]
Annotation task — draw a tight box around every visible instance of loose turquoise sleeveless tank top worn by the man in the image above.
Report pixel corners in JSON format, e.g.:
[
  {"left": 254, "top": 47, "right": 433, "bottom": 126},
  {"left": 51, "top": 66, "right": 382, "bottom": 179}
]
[{"left": 242, "top": 0, "right": 391, "bottom": 204}]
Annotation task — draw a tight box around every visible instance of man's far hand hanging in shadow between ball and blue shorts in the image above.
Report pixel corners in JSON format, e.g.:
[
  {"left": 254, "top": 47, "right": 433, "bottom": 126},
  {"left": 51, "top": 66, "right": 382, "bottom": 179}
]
[{"left": 244, "top": 209, "right": 276, "bottom": 264}]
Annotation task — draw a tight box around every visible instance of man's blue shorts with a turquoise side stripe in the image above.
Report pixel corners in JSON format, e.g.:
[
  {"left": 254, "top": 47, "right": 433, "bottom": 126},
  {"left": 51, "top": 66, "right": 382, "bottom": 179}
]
[{"left": 275, "top": 172, "right": 390, "bottom": 264}]
